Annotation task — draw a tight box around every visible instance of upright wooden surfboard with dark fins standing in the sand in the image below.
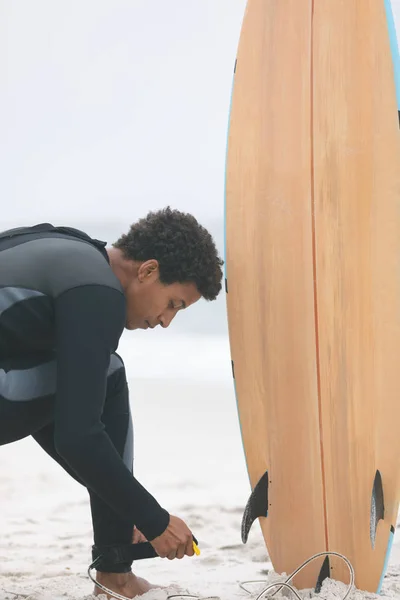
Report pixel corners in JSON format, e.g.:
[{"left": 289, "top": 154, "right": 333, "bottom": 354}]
[{"left": 225, "top": 0, "right": 400, "bottom": 592}]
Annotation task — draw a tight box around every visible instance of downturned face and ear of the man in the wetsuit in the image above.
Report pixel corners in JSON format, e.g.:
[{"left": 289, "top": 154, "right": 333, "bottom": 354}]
[{"left": 125, "top": 260, "right": 201, "bottom": 329}]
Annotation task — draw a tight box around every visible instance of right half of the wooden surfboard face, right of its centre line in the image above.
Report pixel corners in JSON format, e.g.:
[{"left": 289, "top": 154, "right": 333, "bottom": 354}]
[{"left": 313, "top": 0, "right": 400, "bottom": 591}]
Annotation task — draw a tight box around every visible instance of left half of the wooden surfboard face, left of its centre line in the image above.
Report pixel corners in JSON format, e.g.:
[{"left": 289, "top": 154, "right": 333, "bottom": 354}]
[{"left": 226, "top": 0, "right": 326, "bottom": 585}]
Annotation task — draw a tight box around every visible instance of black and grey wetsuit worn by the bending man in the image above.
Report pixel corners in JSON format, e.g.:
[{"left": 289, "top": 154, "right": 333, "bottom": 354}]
[{"left": 0, "top": 224, "right": 169, "bottom": 571}]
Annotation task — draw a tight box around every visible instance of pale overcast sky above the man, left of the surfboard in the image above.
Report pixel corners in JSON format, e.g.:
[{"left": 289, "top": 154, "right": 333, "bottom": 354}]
[{"left": 0, "top": 0, "right": 245, "bottom": 229}]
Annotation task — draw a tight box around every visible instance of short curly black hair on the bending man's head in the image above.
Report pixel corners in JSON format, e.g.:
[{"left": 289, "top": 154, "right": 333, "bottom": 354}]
[{"left": 113, "top": 206, "right": 224, "bottom": 300}]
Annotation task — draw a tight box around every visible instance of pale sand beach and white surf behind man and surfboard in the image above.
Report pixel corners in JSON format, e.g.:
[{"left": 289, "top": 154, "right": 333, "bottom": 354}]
[{"left": 0, "top": 332, "right": 400, "bottom": 600}]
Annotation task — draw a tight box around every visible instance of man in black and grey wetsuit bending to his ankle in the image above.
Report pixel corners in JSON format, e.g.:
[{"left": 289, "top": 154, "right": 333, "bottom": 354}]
[{"left": 0, "top": 208, "right": 223, "bottom": 598}]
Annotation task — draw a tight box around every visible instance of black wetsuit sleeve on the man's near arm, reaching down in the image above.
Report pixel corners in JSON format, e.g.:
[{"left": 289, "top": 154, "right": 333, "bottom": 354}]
[{"left": 54, "top": 285, "right": 169, "bottom": 540}]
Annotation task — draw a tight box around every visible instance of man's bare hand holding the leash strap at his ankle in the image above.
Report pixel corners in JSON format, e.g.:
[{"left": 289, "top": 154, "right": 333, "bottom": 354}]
[{"left": 150, "top": 515, "right": 194, "bottom": 560}]
